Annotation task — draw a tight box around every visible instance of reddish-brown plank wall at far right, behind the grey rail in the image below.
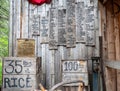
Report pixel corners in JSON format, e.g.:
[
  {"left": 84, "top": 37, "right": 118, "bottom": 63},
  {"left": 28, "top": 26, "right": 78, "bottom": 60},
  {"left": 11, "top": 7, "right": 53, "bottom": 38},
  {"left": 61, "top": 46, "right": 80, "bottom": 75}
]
[{"left": 99, "top": 0, "right": 120, "bottom": 91}]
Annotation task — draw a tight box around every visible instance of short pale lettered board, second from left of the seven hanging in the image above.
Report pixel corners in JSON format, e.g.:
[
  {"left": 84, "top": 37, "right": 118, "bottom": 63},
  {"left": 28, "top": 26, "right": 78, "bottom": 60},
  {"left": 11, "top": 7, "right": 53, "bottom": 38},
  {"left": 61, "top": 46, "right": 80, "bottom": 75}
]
[{"left": 40, "top": 16, "right": 49, "bottom": 43}]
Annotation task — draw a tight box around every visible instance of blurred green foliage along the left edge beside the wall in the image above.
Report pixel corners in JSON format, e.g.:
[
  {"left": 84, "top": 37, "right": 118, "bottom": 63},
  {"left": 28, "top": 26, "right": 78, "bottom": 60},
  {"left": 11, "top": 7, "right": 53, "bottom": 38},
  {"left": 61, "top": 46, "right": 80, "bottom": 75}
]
[{"left": 0, "top": 0, "right": 9, "bottom": 86}]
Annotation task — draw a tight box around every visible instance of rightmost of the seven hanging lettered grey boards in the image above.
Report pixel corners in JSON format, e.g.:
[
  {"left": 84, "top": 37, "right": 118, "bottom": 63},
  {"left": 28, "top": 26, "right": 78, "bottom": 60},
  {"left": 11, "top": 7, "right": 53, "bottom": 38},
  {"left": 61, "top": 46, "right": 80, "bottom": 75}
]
[{"left": 85, "top": 1, "right": 95, "bottom": 46}]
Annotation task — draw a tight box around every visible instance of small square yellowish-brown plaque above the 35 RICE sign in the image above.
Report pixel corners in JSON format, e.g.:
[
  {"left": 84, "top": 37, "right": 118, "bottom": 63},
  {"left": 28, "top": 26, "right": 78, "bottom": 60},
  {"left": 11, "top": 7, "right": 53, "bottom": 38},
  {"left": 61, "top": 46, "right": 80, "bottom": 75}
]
[{"left": 17, "top": 39, "right": 35, "bottom": 57}]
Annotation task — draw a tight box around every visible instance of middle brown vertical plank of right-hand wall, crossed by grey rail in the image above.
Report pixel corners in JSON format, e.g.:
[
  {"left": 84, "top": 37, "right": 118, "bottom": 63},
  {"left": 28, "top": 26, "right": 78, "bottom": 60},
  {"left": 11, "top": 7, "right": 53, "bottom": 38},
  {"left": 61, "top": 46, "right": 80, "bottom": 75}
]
[{"left": 106, "top": 2, "right": 117, "bottom": 91}]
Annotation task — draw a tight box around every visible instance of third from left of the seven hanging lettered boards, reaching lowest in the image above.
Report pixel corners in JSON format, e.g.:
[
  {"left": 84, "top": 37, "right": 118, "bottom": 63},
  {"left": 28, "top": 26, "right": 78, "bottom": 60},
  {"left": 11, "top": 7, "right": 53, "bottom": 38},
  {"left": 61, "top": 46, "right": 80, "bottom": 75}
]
[{"left": 49, "top": 7, "right": 58, "bottom": 49}]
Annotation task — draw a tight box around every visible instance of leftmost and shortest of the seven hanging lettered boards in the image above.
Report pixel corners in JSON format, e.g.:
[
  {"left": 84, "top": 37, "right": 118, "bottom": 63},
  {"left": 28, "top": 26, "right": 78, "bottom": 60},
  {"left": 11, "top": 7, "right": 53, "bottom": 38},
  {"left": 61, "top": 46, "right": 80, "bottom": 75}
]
[{"left": 30, "top": 14, "right": 40, "bottom": 36}]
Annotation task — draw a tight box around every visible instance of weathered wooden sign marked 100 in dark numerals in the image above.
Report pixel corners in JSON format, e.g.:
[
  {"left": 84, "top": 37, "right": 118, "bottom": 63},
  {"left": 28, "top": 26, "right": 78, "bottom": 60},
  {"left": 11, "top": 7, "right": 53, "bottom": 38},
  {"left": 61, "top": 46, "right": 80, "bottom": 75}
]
[{"left": 62, "top": 60, "right": 88, "bottom": 86}]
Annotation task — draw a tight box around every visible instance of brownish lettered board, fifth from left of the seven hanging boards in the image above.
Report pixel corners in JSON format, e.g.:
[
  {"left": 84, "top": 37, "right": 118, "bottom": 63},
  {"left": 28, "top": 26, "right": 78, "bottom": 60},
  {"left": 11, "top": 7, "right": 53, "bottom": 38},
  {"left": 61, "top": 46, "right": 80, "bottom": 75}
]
[{"left": 66, "top": 0, "right": 76, "bottom": 47}]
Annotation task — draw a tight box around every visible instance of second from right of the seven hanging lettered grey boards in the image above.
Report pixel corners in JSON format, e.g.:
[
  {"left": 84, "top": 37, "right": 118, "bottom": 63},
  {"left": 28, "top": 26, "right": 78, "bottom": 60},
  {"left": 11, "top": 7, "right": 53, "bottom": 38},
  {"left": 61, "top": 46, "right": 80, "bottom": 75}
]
[{"left": 75, "top": 1, "right": 86, "bottom": 43}]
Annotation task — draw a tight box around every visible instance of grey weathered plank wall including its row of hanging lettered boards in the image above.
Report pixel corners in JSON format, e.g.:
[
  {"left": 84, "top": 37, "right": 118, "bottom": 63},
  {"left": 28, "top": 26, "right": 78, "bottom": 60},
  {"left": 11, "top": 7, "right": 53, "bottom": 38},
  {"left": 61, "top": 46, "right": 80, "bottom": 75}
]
[{"left": 9, "top": 0, "right": 99, "bottom": 88}]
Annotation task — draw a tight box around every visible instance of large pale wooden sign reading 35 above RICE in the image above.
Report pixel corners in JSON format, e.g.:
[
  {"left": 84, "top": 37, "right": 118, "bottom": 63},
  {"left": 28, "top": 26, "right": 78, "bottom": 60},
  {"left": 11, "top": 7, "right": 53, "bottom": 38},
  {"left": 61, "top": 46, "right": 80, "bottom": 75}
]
[{"left": 3, "top": 57, "right": 36, "bottom": 91}]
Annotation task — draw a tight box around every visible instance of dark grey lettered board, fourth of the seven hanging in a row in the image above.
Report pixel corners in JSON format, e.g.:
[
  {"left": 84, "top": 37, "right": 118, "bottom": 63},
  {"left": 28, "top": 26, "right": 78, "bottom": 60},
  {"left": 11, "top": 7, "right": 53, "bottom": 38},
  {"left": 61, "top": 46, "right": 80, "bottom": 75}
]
[{"left": 58, "top": 9, "right": 66, "bottom": 45}]
